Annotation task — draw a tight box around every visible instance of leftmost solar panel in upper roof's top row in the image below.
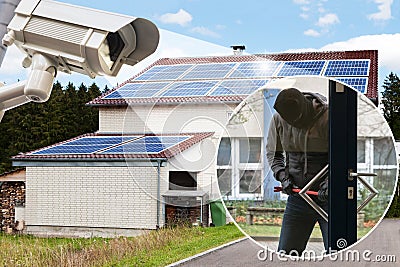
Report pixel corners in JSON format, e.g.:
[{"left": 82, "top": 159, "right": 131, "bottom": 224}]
[{"left": 134, "top": 64, "right": 193, "bottom": 81}]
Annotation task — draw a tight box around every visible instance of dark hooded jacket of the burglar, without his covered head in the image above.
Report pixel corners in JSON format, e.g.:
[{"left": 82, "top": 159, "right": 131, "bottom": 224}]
[{"left": 266, "top": 93, "right": 329, "bottom": 191}]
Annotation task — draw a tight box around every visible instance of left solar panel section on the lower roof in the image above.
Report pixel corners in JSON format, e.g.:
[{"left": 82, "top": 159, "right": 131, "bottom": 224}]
[{"left": 30, "top": 135, "right": 140, "bottom": 155}]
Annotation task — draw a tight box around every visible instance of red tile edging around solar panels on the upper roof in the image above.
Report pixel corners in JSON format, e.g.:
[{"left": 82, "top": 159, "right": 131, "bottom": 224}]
[{"left": 87, "top": 50, "right": 378, "bottom": 106}]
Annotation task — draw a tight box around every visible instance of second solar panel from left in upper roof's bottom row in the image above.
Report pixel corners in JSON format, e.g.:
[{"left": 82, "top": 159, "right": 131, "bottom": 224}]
[{"left": 161, "top": 81, "right": 218, "bottom": 97}]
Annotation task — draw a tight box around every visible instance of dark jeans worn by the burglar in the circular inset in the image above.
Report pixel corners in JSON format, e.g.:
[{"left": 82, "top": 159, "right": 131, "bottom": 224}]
[{"left": 278, "top": 195, "right": 328, "bottom": 256}]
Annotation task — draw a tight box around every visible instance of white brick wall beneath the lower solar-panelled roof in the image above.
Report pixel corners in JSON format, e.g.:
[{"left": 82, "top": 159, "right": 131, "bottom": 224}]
[{"left": 25, "top": 167, "right": 168, "bottom": 229}]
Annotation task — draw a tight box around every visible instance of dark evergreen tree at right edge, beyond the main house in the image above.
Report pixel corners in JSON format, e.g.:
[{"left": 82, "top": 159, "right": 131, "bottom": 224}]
[{"left": 382, "top": 72, "right": 400, "bottom": 140}]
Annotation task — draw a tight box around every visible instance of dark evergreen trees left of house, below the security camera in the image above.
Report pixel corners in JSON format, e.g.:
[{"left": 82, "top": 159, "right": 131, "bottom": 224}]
[{"left": 0, "top": 82, "right": 101, "bottom": 173}]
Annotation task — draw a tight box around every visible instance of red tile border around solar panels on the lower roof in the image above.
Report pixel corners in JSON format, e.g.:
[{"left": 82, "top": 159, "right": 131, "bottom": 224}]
[{"left": 12, "top": 132, "right": 214, "bottom": 161}]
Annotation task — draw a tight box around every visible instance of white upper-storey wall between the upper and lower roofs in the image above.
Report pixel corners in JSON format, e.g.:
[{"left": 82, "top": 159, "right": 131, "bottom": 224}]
[{"left": 99, "top": 103, "right": 236, "bottom": 133}]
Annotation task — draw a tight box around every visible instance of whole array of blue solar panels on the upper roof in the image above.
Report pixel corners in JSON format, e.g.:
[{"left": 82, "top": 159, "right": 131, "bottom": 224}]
[{"left": 103, "top": 59, "right": 370, "bottom": 99}]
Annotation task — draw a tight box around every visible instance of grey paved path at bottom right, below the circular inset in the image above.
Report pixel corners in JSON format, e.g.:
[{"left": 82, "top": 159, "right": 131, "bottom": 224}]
[{"left": 179, "top": 219, "right": 400, "bottom": 267}]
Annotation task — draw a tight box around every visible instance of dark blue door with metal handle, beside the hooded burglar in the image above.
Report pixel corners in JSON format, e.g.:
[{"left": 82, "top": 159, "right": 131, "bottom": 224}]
[{"left": 328, "top": 81, "right": 357, "bottom": 251}]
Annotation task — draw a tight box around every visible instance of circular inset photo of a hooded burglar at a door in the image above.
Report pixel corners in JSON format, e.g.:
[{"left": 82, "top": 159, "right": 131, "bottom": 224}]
[{"left": 216, "top": 76, "right": 398, "bottom": 256}]
